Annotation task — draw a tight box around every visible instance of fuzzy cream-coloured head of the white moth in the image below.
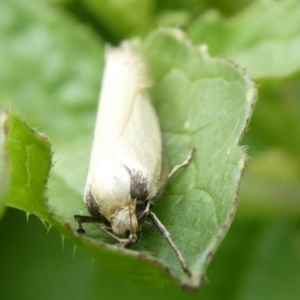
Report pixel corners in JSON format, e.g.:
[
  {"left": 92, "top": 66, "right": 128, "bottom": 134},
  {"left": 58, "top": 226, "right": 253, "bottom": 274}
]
[{"left": 111, "top": 202, "right": 139, "bottom": 240}]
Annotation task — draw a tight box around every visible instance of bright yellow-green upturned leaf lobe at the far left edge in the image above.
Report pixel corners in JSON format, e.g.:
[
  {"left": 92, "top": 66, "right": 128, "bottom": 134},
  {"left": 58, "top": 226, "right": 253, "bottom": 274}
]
[{"left": 1, "top": 111, "right": 51, "bottom": 221}]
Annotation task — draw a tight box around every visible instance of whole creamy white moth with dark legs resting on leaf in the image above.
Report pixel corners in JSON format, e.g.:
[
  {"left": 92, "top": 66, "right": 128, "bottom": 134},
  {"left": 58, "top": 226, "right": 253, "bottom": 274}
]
[{"left": 75, "top": 43, "right": 193, "bottom": 275}]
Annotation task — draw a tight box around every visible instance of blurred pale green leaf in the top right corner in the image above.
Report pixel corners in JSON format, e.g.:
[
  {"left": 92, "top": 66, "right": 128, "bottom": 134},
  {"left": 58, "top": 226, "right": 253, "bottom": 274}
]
[{"left": 188, "top": 0, "right": 300, "bottom": 79}]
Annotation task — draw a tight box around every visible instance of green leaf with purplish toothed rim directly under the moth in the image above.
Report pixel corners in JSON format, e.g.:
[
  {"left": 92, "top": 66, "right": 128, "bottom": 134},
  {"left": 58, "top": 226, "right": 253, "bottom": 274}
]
[{"left": 49, "top": 30, "right": 255, "bottom": 288}]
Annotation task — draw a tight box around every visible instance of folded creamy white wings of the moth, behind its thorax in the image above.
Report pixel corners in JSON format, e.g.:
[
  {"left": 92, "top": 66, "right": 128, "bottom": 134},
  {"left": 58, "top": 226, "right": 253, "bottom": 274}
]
[{"left": 85, "top": 45, "right": 162, "bottom": 202}]
